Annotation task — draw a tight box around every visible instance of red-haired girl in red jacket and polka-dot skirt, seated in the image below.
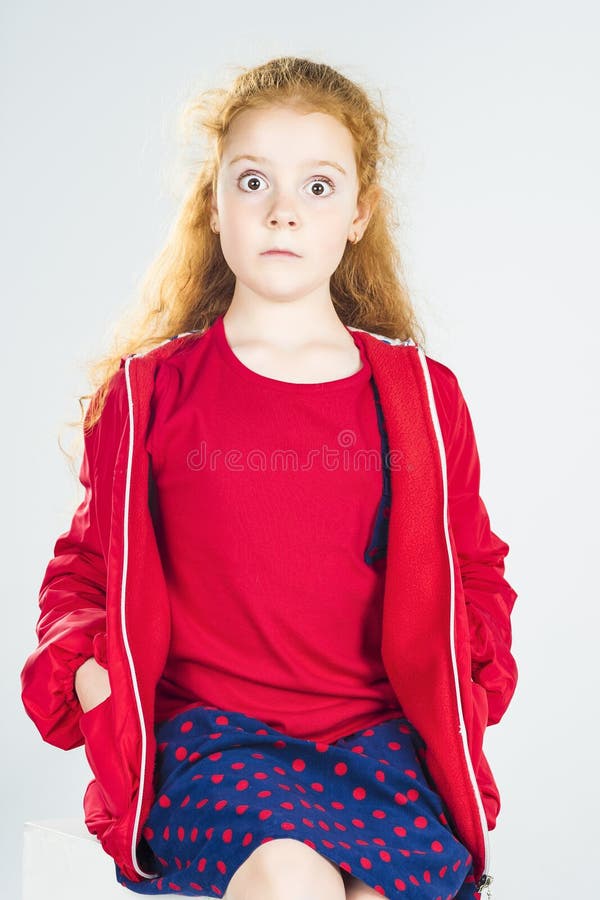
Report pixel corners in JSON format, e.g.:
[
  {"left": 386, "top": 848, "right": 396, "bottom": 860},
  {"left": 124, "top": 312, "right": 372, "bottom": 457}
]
[{"left": 22, "top": 57, "right": 517, "bottom": 900}]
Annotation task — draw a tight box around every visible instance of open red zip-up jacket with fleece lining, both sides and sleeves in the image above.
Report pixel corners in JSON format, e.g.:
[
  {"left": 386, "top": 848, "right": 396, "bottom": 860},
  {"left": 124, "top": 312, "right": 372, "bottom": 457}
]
[{"left": 21, "top": 329, "right": 517, "bottom": 886}]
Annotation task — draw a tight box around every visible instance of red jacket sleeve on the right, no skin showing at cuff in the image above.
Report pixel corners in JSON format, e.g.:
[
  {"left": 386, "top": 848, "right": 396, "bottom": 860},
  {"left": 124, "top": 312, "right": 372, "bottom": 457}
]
[{"left": 432, "top": 363, "right": 518, "bottom": 725}]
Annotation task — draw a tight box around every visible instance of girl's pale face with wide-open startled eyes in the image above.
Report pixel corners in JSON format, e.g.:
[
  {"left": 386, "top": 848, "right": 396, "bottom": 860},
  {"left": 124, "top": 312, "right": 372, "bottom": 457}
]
[{"left": 211, "top": 106, "right": 370, "bottom": 300}]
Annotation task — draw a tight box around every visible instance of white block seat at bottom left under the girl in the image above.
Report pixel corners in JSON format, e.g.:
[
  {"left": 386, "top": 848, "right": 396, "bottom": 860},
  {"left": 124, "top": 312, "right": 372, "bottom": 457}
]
[{"left": 23, "top": 819, "right": 216, "bottom": 900}]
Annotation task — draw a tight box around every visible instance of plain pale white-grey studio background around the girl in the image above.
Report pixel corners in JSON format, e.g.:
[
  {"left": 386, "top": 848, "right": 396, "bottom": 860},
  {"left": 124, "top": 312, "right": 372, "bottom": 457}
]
[{"left": 0, "top": 0, "right": 600, "bottom": 900}]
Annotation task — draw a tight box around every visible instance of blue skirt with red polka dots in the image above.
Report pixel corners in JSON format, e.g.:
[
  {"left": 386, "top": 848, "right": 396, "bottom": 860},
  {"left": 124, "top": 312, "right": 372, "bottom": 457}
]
[{"left": 117, "top": 706, "right": 479, "bottom": 900}]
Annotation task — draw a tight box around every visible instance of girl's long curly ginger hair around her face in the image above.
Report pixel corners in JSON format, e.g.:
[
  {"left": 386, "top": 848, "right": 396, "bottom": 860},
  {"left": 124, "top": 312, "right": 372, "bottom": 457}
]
[{"left": 72, "top": 56, "right": 424, "bottom": 442}]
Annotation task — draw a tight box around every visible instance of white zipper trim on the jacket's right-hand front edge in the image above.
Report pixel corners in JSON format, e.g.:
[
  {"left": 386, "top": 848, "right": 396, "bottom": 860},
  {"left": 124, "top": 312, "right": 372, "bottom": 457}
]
[{"left": 417, "top": 346, "right": 492, "bottom": 897}]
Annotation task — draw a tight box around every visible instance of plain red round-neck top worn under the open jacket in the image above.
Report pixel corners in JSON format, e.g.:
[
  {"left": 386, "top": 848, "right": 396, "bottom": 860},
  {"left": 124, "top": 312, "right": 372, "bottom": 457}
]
[{"left": 146, "top": 316, "right": 402, "bottom": 741}]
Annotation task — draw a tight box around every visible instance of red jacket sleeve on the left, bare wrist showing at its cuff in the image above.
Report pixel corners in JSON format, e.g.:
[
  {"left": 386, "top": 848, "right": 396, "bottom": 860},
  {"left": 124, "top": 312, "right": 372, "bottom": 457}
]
[{"left": 21, "top": 369, "right": 126, "bottom": 750}]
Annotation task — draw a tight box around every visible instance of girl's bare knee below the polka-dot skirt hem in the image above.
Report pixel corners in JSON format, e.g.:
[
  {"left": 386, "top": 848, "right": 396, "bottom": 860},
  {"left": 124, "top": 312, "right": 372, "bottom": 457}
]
[{"left": 224, "top": 838, "right": 346, "bottom": 900}]
